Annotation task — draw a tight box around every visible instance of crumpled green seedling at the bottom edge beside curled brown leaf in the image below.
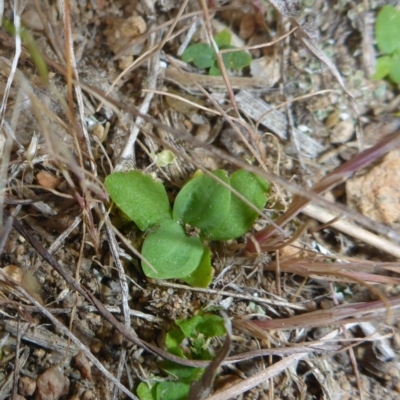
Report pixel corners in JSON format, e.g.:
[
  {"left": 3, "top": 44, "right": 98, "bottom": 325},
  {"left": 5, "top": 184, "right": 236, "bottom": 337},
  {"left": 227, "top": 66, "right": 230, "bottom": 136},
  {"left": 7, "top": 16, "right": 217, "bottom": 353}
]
[{"left": 136, "top": 313, "right": 226, "bottom": 400}]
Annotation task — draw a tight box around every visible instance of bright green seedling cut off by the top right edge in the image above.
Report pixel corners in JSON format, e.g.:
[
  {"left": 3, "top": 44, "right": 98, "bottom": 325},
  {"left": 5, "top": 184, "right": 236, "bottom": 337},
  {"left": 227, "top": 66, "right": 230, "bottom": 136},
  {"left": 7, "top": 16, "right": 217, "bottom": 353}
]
[{"left": 372, "top": 5, "right": 400, "bottom": 84}]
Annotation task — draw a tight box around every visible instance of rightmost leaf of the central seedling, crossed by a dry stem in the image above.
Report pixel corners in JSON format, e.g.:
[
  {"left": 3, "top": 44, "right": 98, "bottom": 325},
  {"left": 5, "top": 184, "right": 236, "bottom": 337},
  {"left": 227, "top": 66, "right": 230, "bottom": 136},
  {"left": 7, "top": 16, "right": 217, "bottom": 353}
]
[{"left": 207, "top": 170, "right": 269, "bottom": 240}]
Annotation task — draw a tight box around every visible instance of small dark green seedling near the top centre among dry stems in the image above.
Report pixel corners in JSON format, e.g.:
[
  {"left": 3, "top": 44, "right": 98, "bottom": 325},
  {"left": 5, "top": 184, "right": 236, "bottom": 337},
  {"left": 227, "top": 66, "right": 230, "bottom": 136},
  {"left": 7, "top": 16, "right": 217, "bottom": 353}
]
[{"left": 182, "top": 30, "right": 251, "bottom": 76}]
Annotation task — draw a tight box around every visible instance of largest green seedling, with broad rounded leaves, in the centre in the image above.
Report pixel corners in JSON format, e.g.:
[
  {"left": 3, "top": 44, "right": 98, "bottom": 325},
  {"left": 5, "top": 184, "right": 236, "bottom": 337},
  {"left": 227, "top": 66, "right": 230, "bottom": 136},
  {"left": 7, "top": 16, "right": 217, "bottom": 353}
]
[{"left": 105, "top": 170, "right": 269, "bottom": 287}]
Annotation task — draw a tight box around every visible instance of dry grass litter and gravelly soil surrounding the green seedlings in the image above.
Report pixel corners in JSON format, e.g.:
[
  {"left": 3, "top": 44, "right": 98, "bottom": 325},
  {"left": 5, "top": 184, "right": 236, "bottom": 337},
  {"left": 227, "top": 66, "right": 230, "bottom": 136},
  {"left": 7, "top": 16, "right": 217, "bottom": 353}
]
[{"left": 0, "top": 0, "right": 400, "bottom": 400}]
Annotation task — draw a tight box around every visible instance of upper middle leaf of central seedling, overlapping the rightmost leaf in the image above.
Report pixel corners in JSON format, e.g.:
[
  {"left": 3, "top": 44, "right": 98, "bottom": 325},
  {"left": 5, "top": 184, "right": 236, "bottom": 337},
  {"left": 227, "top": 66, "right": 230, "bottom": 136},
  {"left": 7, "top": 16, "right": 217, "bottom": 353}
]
[{"left": 173, "top": 170, "right": 231, "bottom": 234}]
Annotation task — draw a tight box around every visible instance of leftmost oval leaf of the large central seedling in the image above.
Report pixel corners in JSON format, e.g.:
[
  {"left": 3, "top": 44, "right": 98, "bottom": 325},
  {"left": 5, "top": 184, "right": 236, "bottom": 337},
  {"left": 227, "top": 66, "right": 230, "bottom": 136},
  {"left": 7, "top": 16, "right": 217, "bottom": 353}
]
[{"left": 105, "top": 171, "right": 171, "bottom": 231}]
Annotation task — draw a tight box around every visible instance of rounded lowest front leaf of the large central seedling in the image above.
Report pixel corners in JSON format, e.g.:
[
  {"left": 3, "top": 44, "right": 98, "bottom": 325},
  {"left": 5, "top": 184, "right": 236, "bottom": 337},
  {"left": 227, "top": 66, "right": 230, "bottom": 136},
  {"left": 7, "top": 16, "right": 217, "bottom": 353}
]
[{"left": 142, "top": 219, "right": 204, "bottom": 279}]
